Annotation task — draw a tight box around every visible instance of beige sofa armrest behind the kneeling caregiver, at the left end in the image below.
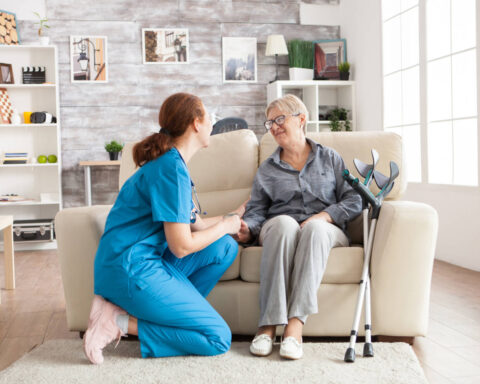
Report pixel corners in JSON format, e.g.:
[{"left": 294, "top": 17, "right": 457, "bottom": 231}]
[{"left": 55, "top": 205, "right": 112, "bottom": 331}]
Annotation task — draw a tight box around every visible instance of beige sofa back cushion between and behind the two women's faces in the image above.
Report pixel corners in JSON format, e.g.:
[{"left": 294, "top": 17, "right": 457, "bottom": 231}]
[{"left": 119, "top": 129, "right": 258, "bottom": 216}]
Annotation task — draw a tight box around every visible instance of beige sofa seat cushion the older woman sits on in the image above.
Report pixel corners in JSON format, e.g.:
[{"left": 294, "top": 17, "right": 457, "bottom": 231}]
[{"left": 240, "top": 246, "right": 363, "bottom": 284}]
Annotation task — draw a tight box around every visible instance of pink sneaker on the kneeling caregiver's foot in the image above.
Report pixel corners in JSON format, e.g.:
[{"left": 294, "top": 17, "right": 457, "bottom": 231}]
[{"left": 83, "top": 295, "right": 126, "bottom": 364}]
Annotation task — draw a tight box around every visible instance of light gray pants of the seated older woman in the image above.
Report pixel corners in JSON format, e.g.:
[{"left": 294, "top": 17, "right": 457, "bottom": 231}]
[{"left": 258, "top": 215, "right": 348, "bottom": 327}]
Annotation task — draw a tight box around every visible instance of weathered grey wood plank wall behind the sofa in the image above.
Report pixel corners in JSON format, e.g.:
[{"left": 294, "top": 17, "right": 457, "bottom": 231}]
[{"left": 19, "top": 0, "right": 340, "bottom": 207}]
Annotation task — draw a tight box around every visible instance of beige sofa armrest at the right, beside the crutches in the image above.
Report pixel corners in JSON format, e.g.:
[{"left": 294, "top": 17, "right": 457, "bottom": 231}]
[{"left": 371, "top": 201, "right": 438, "bottom": 336}]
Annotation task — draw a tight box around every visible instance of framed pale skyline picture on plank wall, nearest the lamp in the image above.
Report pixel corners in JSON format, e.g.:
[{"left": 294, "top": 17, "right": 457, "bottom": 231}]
[{"left": 222, "top": 37, "right": 257, "bottom": 83}]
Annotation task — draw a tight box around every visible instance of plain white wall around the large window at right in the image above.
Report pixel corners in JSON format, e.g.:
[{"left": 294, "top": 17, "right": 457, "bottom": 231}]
[{"left": 300, "top": 0, "right": 480, "bottom": 271}]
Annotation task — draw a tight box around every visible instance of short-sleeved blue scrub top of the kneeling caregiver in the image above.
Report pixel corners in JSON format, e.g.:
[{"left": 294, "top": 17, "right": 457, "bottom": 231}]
[{"left": 94, "top": 148, "right": 194, "bottom": 294}]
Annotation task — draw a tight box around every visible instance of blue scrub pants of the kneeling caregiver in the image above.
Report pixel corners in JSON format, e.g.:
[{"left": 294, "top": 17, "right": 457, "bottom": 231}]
[{"left": 99, "top": 235, "right": 238, "bottom": 357}]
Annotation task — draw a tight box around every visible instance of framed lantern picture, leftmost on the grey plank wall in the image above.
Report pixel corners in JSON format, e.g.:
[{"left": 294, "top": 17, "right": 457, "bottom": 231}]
[{"left": 70, "top": 36, "right": 108, "bottom": 83}]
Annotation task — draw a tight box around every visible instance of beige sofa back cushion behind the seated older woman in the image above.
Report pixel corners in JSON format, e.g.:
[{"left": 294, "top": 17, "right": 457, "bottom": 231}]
[{"left": 260, "top": 131, "right": 407, "bottom": 200}]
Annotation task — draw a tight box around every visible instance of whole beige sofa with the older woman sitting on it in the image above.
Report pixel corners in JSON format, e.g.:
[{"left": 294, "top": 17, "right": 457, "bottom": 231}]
[{"left": 55, "top": 130, "right": 438, "bottom": 337}]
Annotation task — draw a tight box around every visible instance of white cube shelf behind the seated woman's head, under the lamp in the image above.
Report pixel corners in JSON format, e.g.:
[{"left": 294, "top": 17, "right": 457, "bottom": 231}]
[{"left": 267, "top": 80, "right": 356, "bottom": 132}]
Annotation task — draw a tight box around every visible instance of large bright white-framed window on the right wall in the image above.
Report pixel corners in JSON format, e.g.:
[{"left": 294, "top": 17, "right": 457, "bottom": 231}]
[{"left": 382, "top": 0, "right": 478, "bottom": 186}]
